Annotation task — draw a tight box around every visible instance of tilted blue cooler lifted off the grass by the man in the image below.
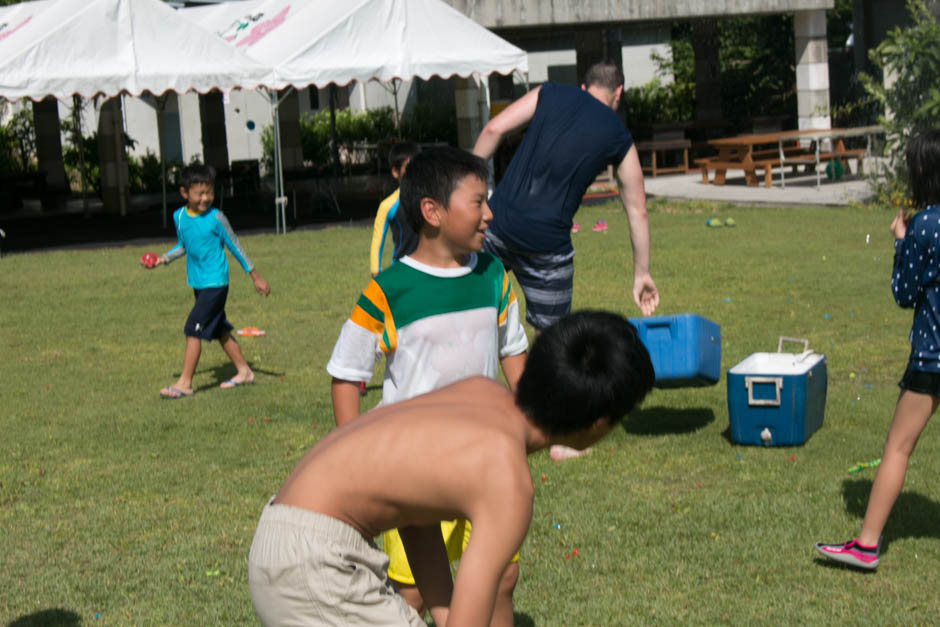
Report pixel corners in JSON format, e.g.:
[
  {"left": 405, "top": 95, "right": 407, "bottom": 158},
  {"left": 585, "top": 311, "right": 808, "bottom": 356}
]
[{"left": 630, "top": 314, "right": 721, "bottom": 388}]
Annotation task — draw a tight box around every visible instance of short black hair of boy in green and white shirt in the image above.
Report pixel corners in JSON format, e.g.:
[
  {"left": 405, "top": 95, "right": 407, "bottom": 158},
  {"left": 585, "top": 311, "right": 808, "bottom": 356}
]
[{"left": 399, "top": 146, "right": 489, "bottom": 234}]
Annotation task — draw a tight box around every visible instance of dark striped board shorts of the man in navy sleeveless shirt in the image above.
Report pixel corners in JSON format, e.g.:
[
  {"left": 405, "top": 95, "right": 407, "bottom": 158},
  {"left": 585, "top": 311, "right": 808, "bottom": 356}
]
[{"left": 483, "top": 231, "right": 574, "bottom": 331}]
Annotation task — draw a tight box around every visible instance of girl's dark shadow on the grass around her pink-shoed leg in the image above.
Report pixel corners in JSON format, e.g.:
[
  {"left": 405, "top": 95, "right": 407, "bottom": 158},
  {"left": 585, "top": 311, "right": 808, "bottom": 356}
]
[{"left": 842, "top": 479, "right": 940, "bottom": 549}]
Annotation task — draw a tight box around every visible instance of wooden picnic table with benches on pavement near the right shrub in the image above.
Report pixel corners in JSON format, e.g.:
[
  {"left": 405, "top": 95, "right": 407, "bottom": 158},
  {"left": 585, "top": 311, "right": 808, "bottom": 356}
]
[{"left": 696, "top": 126, "right": 884, "bottom": 187}]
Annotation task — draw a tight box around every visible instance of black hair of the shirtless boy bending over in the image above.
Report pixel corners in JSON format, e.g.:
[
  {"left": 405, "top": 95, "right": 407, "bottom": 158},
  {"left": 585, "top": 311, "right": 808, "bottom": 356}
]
[{"left": 516, "top": 311, "right": 654, "bottom": 436}]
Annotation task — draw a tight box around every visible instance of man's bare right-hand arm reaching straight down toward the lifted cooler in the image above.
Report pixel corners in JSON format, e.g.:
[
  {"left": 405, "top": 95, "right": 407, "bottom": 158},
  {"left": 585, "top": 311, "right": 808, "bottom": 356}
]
[{"left": 617, "top": 146, "right": 659, "bottom": 316}]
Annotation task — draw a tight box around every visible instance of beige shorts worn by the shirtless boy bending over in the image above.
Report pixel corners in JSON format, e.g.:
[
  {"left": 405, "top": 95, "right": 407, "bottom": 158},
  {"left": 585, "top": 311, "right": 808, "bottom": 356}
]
[{"left": 248, "top": 502, "right": 425, "bottom": 627}]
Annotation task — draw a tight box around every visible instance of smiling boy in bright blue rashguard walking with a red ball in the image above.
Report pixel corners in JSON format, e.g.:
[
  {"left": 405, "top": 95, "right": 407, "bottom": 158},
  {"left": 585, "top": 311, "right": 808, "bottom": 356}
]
[{"left": 154, "top": 164, "right": 271, "bottom": 399}]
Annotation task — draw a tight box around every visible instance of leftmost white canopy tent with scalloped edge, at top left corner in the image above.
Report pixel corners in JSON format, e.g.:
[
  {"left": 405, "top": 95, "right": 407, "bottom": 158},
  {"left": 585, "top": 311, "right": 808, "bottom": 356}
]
[{"left": 0, "top": 0, "right": 274, "bottom": 225}]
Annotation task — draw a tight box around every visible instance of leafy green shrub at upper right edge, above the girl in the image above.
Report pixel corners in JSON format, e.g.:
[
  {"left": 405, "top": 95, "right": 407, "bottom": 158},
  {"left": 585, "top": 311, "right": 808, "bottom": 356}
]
[{"left": 859, "top": 0, "right": 940, "bottom": 202}]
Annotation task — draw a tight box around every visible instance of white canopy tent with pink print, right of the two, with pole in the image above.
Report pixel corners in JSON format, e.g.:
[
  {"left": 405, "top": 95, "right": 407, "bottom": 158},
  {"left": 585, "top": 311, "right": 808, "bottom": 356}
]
[{"left": 181, "top": 0, "right": 528, "bottom": 233}]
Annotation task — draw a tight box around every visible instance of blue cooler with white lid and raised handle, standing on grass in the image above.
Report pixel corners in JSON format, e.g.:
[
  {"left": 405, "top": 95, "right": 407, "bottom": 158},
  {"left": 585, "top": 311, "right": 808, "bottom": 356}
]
[{"left": 727, "top": 337, "right": 826, "bottom": 446}]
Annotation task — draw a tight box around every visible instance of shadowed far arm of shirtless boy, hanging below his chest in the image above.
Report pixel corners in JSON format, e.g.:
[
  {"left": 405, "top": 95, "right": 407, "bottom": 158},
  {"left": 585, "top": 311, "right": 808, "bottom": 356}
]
[{"left": 398, "top": 523, "right": 454, "bottom": 625}]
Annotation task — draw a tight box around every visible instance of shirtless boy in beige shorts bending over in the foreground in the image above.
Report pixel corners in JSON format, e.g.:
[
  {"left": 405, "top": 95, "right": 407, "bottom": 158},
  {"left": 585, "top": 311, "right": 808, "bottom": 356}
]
[{"left": 248, "top": 312, "right": 653, "bottom": 627}]
